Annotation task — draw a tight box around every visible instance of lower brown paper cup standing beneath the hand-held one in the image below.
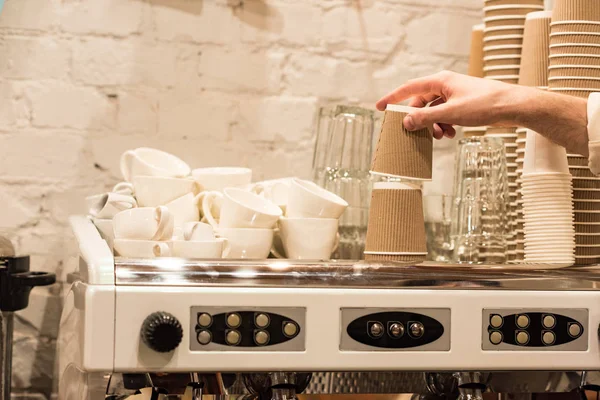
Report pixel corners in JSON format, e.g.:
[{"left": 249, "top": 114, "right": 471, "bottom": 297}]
[{"left": 365, "top": 189, "right": 427, "bottom": 253}]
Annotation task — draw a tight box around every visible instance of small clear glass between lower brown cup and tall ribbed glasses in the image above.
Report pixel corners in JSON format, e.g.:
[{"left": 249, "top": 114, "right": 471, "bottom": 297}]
[{"left": 423, "top": 195, "right": 453, "bottom": 262}]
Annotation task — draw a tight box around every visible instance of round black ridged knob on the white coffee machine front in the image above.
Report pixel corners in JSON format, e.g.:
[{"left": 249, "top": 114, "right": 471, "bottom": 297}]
[{"left": 141, "top": 311, "right": 183, "bottom": 353}]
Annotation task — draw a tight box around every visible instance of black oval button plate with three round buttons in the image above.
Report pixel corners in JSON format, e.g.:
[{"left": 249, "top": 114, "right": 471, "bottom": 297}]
[{"left": 346, "top": 311, "right": 444, "bottom": 349}]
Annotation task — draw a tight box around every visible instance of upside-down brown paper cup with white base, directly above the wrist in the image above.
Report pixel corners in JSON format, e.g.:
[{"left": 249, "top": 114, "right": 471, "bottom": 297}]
[{"left": 519, "top": 11, "right": 552, "bottom": 87}]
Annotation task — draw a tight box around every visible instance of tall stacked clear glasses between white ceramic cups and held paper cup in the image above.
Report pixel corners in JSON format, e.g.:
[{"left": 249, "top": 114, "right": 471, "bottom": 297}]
[{"left": 313, "top": 105, "right": 374, "bottom": 260}]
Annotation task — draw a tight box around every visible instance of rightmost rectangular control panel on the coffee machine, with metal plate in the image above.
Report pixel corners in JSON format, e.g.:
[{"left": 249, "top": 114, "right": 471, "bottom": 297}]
[{"left": 482, "top": 309, "right": 588, "bottom": 351}]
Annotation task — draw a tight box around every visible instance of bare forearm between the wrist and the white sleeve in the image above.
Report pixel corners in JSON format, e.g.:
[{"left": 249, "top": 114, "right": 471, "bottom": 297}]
[{"left": 507, "top": 88, "right": 588, "bottom": 156}]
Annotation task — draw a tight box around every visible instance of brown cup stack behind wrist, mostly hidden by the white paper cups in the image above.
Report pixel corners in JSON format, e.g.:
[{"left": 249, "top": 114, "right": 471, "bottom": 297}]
[{"left": 509, "top": 11, "right": 552, "bottom": 261}]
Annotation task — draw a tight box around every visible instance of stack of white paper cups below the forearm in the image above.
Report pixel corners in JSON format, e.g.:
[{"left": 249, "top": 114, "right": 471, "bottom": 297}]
[{"left": 522, "top": 130, "right": 575, "bottom": 266}]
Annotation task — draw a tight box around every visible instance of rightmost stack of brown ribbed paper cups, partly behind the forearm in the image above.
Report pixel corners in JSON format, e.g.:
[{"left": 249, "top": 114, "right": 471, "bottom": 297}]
[{"left": 548, "top": 0, "right": 600, "bottom": 265}]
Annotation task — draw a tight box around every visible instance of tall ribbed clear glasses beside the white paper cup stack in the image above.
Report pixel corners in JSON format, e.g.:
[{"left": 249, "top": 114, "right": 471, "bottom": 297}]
[{"left": 451, "top": 137, "right": 511, "bottom": 263}]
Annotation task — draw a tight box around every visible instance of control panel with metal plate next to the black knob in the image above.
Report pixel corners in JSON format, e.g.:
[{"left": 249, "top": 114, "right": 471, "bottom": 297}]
[{"left": 190, "top": 306, "right": 306, "bottom": 352}]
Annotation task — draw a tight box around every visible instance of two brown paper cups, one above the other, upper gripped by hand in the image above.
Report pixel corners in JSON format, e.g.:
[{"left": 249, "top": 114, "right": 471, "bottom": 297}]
[{"left": 365, "top": 104, "right": 433, "bottom": 262}]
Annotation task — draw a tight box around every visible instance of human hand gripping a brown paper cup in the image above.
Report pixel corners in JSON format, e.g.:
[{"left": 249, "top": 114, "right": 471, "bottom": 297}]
[{"left": 377, "top": 71, "right": 535, "bottom": 139}]
